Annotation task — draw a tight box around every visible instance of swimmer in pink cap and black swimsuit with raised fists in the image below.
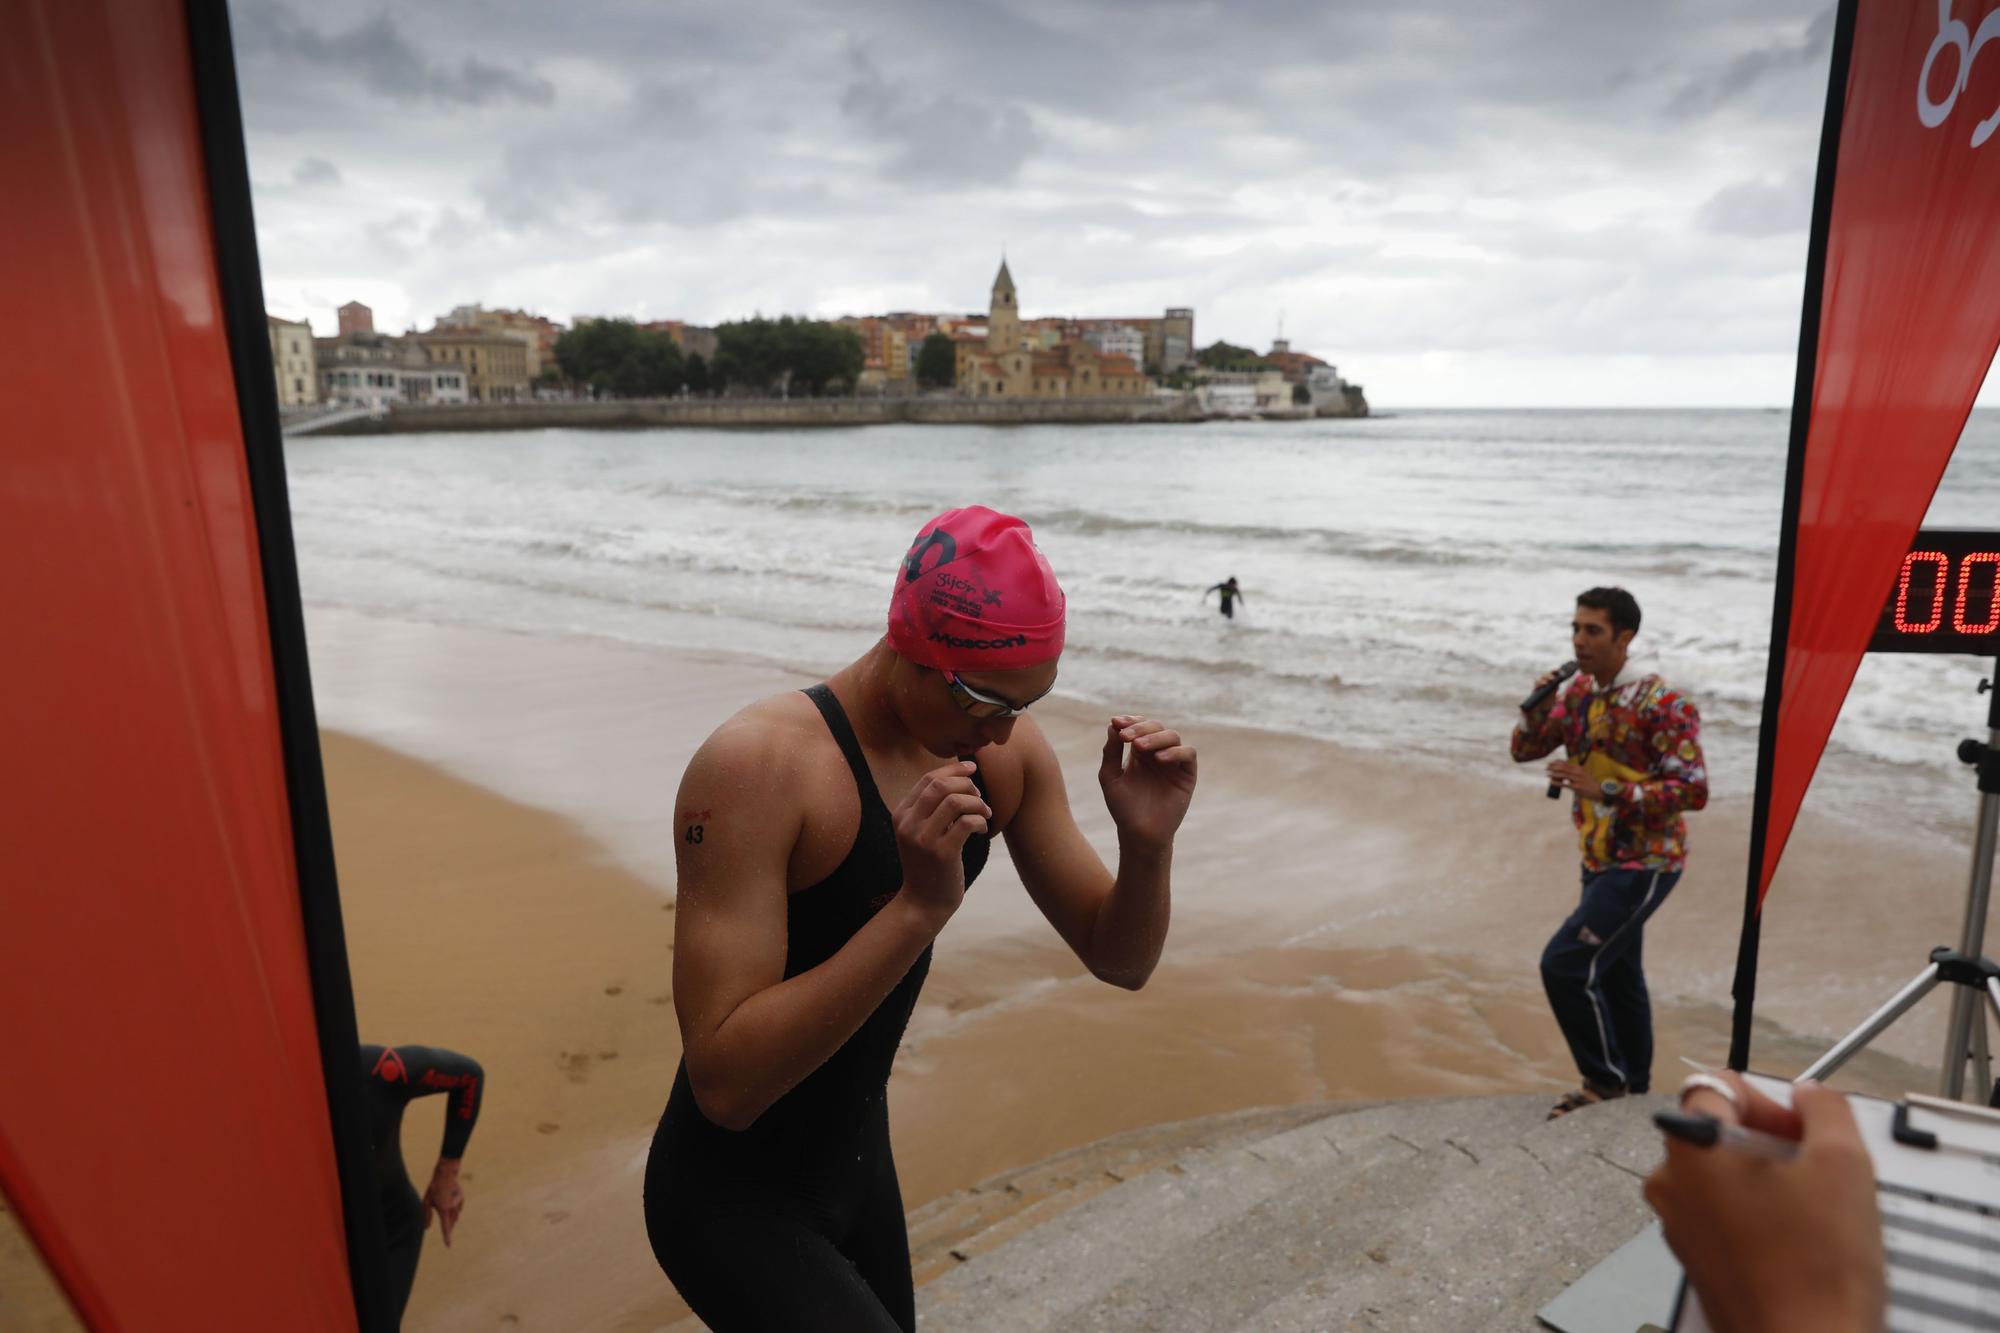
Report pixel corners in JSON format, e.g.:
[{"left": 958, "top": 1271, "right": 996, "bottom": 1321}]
[{"left": 646, "top": 506, "right": 1196, "bottom": 1333}]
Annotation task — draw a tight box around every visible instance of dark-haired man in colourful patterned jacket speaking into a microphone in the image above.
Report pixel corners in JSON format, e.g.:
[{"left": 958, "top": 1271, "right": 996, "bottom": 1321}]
[{"left": 1510, "top": 588, "right": 1708, "bottom": 1119}]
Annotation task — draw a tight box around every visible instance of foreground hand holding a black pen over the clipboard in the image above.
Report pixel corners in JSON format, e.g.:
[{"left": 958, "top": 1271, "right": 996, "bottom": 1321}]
[{"left": 1646, "top": 1073, "right": 1886, "bottom": 1333}]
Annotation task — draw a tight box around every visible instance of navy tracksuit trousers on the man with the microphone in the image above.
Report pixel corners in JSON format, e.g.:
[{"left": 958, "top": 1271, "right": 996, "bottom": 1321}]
[{"left": 1542, "top": 869, "right": 1680, "bottom": 1093}]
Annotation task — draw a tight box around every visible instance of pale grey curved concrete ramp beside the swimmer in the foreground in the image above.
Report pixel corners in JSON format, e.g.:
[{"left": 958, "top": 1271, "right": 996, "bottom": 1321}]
[{"left": 910, "top": 1093, "right": 1664, "bottom": 1333}]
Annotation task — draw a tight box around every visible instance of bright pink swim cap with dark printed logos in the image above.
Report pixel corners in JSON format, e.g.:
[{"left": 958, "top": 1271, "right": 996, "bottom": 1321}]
[{"left": 888, "top": 504, "right": 1064, "bottom": 671}]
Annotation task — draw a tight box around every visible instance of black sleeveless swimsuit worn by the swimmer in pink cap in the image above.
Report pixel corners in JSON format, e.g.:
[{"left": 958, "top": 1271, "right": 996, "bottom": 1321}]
[{"left": 646, "top": 685, "right": 990, "bottom": 1333}]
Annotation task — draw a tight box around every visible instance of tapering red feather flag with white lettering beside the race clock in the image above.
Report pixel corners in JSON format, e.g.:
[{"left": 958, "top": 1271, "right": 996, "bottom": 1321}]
[{"left": 1732, "top": 0, "right": 2000, "bottom": 1067}]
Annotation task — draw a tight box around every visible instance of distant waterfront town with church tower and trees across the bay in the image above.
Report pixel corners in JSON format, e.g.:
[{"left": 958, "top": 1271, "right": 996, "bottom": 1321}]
[{"left": 282, "top": 258, "right": 1368, "bottom": 420}]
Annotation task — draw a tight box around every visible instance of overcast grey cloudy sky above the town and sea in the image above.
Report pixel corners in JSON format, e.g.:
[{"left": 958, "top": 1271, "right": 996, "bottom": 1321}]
[{"left": 230, "top": 0, "right": 1832, "bottom": 408}]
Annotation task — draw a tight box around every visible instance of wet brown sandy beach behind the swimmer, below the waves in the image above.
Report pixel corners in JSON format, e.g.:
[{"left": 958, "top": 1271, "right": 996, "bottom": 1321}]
[{"left": 290, "top": 616, "right": 1964, "bottom": 1329}]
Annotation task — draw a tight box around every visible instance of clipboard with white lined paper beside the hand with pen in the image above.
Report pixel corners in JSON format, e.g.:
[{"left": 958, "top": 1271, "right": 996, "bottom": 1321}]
[{"left": 1668, "top": 1075, "right": 2000, "bottom": 1333}]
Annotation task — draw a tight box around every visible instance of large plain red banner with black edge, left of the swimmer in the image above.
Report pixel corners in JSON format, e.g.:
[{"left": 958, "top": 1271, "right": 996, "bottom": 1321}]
[{"left": 0, "top": 0, "right": 392, "bottom": 1333}]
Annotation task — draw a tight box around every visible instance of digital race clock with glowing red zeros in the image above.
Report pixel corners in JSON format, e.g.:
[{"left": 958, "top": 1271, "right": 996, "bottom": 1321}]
[{"left": 1868, "top": 528, "right": 2000, "bottom": 656}]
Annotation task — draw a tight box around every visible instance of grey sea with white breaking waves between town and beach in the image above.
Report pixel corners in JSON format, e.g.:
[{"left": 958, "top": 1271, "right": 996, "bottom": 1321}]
[{"left": 286, "top": 410, "right": 2000, "bottom": 841}]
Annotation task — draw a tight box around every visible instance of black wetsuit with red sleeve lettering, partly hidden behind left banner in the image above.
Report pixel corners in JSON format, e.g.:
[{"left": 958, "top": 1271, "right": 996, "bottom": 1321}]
[{"left": 362, "top": 1047, "right": 486, "bottom": 1321}]
